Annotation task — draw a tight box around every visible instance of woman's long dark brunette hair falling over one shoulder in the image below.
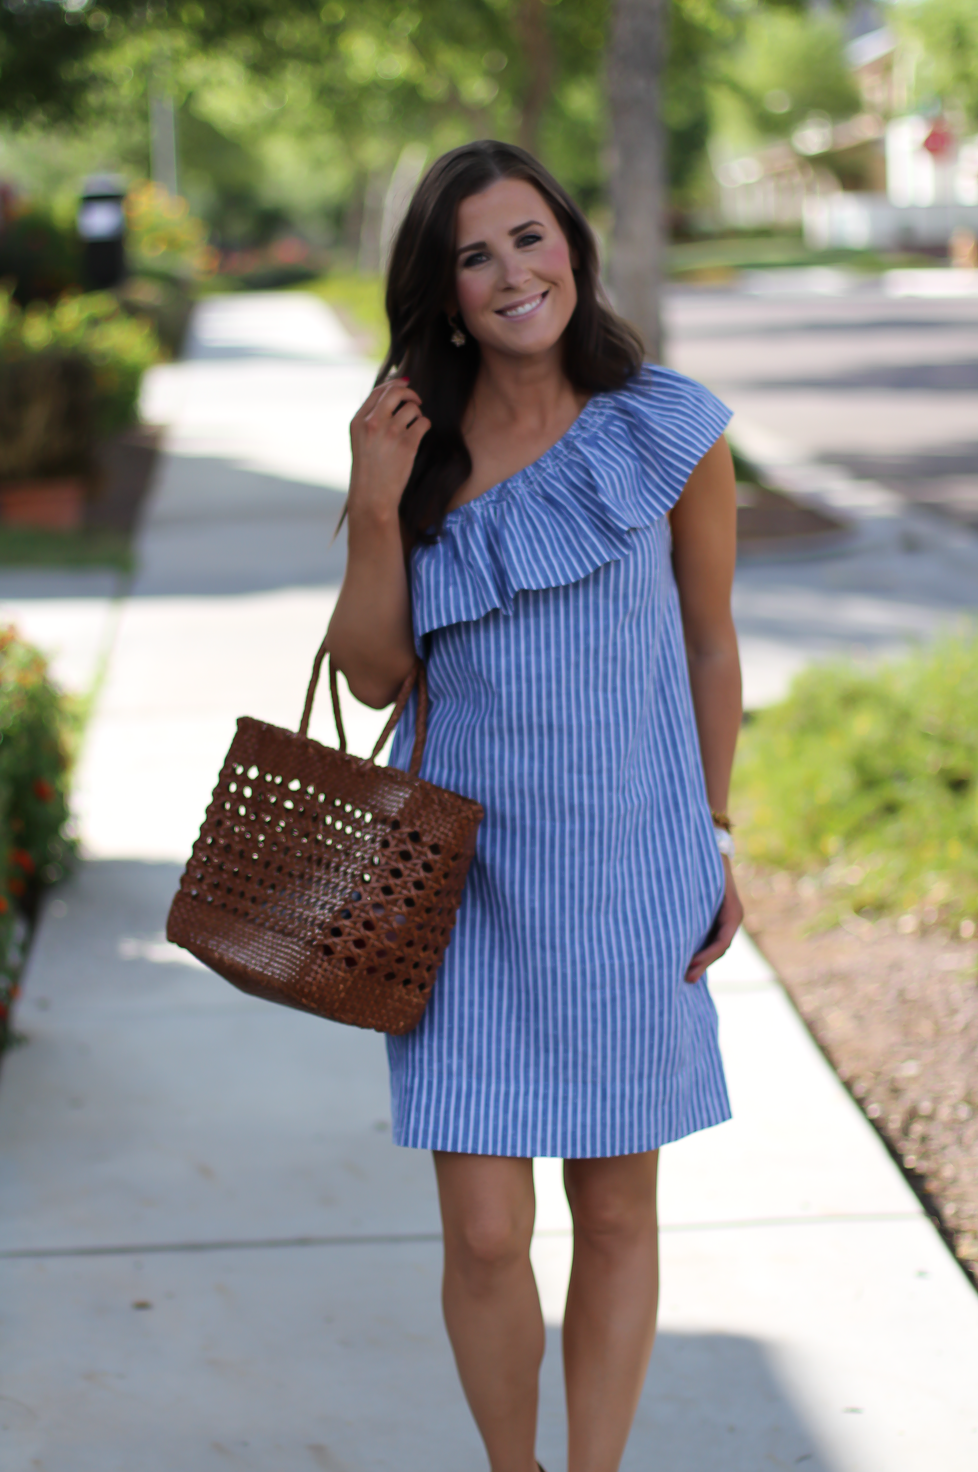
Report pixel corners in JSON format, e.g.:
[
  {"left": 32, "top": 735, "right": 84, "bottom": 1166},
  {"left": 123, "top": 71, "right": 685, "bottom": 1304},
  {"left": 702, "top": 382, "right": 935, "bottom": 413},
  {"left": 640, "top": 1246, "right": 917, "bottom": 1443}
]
[{"left": 377, "top": 140, "right": 644, "bottom": 542}]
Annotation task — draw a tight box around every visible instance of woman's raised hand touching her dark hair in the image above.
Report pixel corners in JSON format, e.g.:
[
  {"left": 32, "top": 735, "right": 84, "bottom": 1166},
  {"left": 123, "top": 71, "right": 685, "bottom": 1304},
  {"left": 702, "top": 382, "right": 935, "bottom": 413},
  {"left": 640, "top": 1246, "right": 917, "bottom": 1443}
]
[{"left": 349, "top": 378, "right": 432, "bottom": 518}]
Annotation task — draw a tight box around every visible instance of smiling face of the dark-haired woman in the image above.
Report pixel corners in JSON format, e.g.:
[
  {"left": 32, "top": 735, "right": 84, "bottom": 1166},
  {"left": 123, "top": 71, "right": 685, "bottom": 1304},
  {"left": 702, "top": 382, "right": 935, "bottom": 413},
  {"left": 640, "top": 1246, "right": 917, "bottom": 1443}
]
[{"left": 455, "top": 180, "right": 577, "bottom": 358}]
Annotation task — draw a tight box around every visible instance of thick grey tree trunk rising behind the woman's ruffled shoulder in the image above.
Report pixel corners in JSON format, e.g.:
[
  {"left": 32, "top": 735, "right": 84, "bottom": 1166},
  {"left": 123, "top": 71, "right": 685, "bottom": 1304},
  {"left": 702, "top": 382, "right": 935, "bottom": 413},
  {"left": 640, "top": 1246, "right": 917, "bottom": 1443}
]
[{"left": 608, "top": 0, "right": 669, "bottom": 362}]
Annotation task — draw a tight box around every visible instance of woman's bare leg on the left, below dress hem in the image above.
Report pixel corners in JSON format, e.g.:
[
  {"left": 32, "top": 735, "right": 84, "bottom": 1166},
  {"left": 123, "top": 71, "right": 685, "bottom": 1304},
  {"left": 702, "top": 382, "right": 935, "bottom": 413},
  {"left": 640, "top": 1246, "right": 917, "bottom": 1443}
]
[{"left": 435, "top": 1151, "right": 545, "bottom": 1472}]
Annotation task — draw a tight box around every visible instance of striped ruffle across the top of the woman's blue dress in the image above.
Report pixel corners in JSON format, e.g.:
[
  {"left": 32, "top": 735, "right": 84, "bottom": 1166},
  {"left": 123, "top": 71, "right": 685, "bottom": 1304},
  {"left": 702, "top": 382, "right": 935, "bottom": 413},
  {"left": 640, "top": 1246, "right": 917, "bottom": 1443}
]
[{"left": 411, "top": 365, "right": 732, "bottom": 652}]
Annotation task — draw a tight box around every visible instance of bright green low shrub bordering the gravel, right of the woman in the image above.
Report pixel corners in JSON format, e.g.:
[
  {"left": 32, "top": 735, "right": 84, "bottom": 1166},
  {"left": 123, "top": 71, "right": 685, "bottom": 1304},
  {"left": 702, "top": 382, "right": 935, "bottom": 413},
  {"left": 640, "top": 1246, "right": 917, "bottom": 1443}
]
[{"left": 735, "top": 634, "right": 978, "bottom": 923}]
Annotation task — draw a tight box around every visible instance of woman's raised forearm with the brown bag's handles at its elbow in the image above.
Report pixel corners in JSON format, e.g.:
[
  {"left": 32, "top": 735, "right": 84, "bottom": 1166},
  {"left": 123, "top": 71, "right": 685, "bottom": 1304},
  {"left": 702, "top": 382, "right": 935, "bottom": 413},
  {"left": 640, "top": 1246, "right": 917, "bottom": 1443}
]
[{"left": 327, "top": 512, "right": 414, "bottom": 710}]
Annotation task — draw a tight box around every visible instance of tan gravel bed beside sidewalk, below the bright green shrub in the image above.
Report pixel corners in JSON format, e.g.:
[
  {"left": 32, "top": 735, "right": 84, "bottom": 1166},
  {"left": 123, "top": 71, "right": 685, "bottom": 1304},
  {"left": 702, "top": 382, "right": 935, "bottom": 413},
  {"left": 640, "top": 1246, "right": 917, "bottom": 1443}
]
[{"left": 738, "top": 864, "right": 978, "bottom": 1287}]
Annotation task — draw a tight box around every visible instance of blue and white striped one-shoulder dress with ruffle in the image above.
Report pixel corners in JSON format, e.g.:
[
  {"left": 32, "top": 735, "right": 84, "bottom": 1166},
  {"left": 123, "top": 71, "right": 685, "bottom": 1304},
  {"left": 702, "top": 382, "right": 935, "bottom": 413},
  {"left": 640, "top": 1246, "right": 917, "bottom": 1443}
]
[{"left": 387, "top": 367, "right": 731, "bottom": 1158}]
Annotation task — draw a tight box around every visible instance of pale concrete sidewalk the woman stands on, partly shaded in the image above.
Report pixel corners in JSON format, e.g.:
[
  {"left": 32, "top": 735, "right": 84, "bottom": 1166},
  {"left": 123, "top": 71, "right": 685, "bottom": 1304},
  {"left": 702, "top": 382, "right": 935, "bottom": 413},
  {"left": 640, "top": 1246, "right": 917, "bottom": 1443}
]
[{"left": 0, "top": 296, "right": 978, "bottom": 1472}]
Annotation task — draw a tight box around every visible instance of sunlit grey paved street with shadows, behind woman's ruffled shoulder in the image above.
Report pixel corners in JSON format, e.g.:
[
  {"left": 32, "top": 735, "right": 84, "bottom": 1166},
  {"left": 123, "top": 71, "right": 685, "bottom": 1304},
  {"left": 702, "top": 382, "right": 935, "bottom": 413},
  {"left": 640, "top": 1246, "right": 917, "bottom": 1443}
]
[{"left": 667, "top": 281, "right": 978, "bottom": 528}]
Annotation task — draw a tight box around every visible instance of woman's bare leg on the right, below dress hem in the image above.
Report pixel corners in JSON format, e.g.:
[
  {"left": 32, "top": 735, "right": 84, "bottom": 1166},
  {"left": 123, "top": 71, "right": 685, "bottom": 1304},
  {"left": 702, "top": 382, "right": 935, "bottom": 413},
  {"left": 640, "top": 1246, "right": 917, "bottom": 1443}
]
[{"left": 564, "top": 1151, "right": 658, "bottom": 1472}]
